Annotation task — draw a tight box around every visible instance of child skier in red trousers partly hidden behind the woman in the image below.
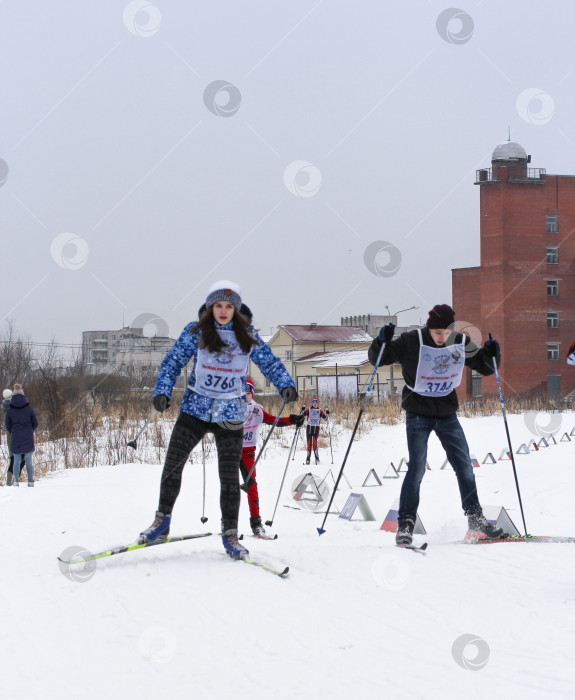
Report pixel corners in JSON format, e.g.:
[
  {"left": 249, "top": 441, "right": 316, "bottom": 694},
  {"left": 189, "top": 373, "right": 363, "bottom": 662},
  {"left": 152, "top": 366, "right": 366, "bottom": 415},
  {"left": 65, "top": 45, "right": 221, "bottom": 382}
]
[{"left": 240, "top": 379, "right": 305, "bottom": 538}]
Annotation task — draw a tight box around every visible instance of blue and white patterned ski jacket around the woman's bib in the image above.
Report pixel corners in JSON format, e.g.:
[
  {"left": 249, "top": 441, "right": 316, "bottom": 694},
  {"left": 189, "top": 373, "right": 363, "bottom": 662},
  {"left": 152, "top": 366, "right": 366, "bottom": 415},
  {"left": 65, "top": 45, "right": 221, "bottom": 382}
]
[{"left": 154, "top": 321, "right": 295, "bottom": 423}]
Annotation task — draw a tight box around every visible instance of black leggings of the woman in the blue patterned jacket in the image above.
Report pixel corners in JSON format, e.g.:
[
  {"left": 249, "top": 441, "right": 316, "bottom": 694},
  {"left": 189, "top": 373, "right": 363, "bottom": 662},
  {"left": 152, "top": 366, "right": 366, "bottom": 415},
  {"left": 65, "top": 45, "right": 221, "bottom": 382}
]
[{"left": 158, "top": 413, "right": 244, "bottom": 531}]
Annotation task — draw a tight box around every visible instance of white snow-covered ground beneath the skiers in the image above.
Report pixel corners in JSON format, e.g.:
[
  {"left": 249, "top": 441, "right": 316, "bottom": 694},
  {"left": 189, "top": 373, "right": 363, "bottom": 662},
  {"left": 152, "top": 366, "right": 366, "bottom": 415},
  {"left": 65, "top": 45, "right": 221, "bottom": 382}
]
[{"left": 0, "top": 413, "right": 575, "bottom": 700}]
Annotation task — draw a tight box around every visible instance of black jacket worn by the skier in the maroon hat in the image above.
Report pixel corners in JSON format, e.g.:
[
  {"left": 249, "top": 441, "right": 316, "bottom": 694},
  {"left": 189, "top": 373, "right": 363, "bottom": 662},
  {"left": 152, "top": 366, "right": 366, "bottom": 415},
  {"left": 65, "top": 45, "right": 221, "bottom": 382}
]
[{"left": 368, "top": 328, "right": 500, "bottom": 418}]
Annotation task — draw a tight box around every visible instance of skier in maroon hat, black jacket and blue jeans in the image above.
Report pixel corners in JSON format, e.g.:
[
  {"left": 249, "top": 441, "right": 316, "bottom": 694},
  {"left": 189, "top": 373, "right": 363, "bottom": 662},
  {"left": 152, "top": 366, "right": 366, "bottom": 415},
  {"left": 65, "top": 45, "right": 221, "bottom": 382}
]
[{"left": 368, "top": 304, "right": 503, "bottom": 544}]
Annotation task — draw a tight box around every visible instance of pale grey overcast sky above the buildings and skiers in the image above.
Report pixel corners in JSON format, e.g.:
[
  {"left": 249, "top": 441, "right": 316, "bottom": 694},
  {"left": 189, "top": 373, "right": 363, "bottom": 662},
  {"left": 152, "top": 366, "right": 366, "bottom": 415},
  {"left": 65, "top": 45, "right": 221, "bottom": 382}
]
[{"left": 0, "top": 0, "right": 575, "bottom": 352}]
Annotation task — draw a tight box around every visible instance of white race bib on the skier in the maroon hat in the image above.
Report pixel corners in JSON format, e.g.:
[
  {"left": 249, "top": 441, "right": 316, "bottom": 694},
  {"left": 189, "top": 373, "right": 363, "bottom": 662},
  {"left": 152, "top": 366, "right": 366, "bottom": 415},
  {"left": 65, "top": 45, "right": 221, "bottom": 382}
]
[{"left": 413, "top": 329, "right": 465, "bottom": 396}]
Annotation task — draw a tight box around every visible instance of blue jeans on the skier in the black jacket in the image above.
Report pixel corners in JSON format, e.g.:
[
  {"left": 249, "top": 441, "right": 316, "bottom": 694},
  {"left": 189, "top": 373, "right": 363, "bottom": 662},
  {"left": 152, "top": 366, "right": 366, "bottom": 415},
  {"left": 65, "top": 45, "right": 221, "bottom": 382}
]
[{"left": 398, "top": 412, "right": 481, "bottom": 520}]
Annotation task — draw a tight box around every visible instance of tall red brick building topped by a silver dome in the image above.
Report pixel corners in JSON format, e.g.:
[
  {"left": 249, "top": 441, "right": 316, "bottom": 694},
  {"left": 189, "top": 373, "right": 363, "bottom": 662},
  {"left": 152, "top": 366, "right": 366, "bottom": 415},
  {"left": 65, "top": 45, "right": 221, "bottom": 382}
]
[{"left": 452, "top": 141, "right": 575, "bottom": 396}]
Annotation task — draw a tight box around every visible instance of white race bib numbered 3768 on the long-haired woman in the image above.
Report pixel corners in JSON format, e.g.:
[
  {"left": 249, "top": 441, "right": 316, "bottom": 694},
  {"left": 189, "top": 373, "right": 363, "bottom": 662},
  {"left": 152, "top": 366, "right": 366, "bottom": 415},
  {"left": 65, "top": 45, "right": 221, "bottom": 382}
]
[{"left": 194, "top": 330, "right": 249, "bottom": 399}]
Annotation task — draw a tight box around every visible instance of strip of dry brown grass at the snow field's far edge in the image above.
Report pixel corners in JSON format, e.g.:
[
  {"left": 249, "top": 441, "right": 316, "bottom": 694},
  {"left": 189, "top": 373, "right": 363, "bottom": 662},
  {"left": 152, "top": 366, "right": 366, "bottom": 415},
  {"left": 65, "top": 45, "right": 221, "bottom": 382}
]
[{"left": 0, "top": 397, "right": 572, "bottom": 481}]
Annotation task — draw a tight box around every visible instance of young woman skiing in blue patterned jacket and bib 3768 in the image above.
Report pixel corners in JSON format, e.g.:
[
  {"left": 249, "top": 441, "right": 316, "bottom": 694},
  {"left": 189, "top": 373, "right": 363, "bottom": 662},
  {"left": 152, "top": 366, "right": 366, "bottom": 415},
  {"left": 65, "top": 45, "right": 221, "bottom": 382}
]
[{"left": 139, "top": 280, "right": 297, "bottom": 559}]
